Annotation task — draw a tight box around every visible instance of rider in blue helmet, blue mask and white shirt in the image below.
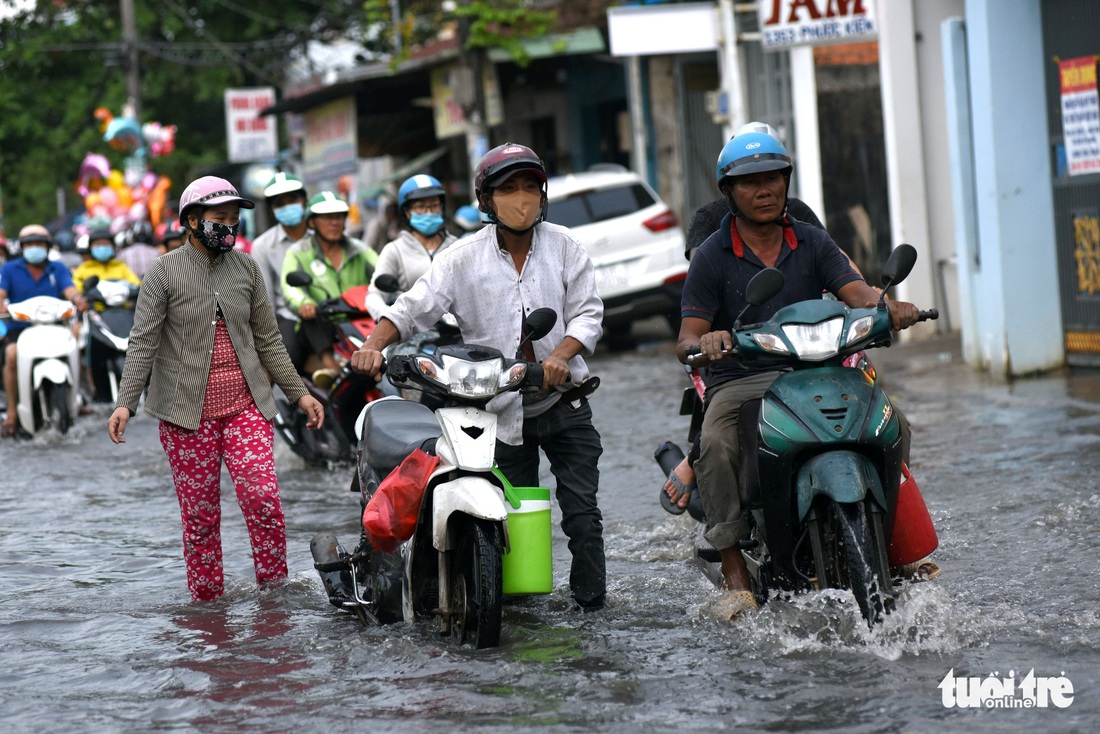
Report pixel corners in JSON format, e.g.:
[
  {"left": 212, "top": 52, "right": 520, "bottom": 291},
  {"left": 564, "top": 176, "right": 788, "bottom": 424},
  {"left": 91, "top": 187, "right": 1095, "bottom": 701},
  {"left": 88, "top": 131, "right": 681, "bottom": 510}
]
[{"left": 366, "top": 174, "right": 455, "bottom": 321}]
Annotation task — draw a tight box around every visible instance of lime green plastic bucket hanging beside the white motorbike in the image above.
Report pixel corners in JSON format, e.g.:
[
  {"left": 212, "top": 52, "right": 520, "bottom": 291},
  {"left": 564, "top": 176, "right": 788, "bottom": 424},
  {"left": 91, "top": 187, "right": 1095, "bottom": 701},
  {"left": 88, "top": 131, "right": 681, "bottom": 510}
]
[{"left": 503, "top": 486, "right": 553, "bottom": 594}]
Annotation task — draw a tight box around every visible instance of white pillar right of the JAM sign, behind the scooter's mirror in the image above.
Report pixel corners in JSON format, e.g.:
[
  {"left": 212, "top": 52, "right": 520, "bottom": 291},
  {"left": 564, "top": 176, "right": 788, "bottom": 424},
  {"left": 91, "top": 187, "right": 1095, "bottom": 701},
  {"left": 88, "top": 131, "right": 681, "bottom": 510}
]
[{"left": 878, "top": 0, "right": 937, "bottom": 337}]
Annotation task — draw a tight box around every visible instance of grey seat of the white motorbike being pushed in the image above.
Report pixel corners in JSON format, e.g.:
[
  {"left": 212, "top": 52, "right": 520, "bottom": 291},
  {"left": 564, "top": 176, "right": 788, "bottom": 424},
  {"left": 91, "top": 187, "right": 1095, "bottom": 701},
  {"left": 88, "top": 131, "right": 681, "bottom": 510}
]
[{"left": 359, "top": 398, "right": 440, "bottom": 476}]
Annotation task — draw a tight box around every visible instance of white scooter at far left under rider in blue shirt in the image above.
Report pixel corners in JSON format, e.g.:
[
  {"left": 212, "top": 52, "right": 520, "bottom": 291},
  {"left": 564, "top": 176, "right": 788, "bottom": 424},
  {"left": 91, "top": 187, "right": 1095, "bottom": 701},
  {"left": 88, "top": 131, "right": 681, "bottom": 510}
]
[{"left": 8, "top": 296, "right": 80, "bottom": 436}]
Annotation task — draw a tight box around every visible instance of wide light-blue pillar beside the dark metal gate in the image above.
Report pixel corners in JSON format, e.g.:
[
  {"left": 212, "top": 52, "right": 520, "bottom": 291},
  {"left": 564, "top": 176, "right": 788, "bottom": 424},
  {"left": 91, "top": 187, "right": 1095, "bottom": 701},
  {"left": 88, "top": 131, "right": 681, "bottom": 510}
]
[{"left": 966, "top": 0, "right": 1065, "bottom": 375}]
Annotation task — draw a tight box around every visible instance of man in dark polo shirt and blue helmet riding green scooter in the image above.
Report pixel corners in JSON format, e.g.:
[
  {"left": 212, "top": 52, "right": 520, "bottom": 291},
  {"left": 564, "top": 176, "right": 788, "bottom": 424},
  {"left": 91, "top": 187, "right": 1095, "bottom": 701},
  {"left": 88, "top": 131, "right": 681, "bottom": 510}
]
[{"left": 673, "top": 132, "right": 920, "bottom": 621}]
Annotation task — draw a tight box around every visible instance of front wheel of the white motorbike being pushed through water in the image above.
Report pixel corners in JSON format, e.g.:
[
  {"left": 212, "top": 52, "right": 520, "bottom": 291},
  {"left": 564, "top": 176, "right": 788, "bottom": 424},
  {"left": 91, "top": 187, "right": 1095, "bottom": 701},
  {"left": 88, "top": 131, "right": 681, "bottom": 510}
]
[{"left": 450, "top": 517, "right": 504, "bottom": 648}]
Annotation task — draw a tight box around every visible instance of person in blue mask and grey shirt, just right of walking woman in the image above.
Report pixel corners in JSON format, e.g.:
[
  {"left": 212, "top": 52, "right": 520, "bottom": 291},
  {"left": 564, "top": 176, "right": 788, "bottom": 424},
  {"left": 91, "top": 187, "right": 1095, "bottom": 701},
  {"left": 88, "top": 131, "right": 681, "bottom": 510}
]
[{"left": 252, "top": 171, "right": 309, "bottom": 372}]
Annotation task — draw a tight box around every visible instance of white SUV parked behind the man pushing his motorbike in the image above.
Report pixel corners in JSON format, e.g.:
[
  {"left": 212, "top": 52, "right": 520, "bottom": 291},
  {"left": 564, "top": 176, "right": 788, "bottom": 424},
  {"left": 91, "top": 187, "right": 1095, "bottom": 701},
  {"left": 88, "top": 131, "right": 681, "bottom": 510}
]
[{"left": 547, "top": 164, "right": 688, "bottom": 341}]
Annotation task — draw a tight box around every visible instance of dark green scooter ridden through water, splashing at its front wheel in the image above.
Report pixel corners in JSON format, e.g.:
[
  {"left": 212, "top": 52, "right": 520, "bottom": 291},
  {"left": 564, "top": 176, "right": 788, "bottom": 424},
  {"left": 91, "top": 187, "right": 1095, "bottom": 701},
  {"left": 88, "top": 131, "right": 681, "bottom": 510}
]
[{"left": 657, "top": 244, "right": 938, "bottom": 625}]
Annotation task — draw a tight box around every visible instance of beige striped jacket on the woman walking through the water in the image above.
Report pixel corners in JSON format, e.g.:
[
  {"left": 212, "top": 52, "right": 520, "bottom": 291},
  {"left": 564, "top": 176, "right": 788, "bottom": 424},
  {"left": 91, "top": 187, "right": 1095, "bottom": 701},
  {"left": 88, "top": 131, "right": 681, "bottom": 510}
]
[{"left": 119, "top": 243, "right": 306, "bottom": 430}]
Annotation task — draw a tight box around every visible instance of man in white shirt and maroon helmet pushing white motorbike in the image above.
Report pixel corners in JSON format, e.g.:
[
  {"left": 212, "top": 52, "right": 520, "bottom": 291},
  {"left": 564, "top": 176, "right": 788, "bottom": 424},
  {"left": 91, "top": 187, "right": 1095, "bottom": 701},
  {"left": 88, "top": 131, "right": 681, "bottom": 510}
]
[{"left": 351, "top": 143, "right": 606, "bottom": 611}]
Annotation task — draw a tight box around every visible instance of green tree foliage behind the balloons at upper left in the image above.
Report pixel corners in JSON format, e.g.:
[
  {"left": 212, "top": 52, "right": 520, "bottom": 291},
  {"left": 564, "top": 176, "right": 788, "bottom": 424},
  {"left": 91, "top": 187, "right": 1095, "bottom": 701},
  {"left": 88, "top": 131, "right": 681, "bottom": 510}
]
[{"left": 0, "top": 0, "right": 362, "bottom": 231}]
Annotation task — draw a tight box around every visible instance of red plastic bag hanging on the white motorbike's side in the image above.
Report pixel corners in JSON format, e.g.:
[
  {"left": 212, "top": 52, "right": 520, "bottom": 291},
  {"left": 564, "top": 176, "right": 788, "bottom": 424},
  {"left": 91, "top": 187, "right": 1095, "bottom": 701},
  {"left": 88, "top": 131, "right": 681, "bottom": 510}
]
[{"left": 363, "top": 449, "right": 439, "bottom": 554}]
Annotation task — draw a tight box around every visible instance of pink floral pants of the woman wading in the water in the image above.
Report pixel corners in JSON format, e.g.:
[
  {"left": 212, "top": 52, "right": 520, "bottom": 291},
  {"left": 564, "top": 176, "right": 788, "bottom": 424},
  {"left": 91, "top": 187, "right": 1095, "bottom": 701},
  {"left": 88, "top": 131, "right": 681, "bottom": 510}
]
[{"left": 161, "top": 404, "right": 287, "bottom": 601}]
